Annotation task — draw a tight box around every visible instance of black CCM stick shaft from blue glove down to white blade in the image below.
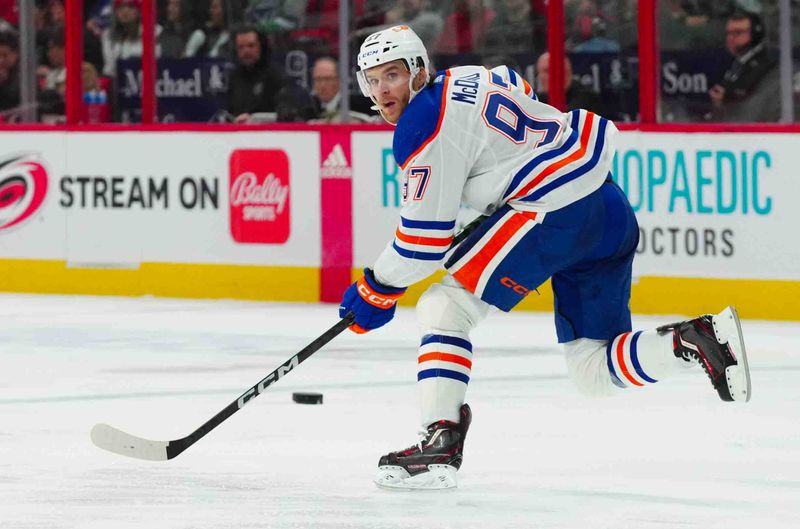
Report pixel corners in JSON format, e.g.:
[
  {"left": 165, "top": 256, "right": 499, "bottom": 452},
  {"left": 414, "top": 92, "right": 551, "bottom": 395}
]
[{"left": 167, "top": 313, "right": 354, "bottom": 459}]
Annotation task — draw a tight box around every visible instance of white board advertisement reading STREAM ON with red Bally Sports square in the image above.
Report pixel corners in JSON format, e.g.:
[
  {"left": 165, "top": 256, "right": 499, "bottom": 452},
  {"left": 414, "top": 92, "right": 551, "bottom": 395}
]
[{"left": 0, "top": 132, "right": 321, "bottom": 267}]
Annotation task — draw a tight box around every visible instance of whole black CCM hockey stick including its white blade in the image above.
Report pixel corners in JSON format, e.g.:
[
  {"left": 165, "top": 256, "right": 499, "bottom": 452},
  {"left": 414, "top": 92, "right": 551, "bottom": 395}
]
[{"left": 91, "top": 213, "right": 485, "bottom": 461}]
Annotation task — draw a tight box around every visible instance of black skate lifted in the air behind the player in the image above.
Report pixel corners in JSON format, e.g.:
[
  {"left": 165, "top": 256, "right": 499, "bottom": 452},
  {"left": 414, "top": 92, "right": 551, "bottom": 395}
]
[{"left": 658, "top": 307, "right": 751, "bottom": 402}]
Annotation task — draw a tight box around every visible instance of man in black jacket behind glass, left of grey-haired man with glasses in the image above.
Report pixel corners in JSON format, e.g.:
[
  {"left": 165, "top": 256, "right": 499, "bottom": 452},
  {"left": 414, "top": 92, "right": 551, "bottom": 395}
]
[{"left": 228, "top": 27, "right": 285, "bottom": 123}]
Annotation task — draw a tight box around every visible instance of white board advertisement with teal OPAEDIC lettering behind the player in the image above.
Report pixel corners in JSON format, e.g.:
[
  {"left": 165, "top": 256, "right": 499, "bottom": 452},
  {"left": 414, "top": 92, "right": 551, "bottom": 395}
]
[{"left": 353, "top": 131, "right": 800, "bottom": 281}]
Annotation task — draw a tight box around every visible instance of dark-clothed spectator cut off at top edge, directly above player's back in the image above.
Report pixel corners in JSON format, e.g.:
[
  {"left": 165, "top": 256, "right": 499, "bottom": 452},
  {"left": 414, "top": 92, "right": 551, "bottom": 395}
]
[{"left": 481, "top": 0, "right": 544, "bottom": 55}]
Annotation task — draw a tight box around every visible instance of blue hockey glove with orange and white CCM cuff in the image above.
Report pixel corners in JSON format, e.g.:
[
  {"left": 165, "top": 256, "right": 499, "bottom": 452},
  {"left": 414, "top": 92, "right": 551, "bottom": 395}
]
[{"left": 339, "top": 268, "right": 406, "bottom": 334}]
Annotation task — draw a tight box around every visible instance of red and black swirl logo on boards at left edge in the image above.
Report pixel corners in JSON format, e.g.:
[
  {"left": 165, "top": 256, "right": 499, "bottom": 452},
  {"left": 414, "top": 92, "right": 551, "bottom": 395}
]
[{"left": 0, "top": 153, "right": 47, "bottom": 231}]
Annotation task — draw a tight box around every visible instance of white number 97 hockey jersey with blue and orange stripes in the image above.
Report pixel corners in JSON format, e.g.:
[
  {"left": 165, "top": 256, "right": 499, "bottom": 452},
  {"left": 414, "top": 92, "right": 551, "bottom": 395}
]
[{"left": 374, "top": 66, "right": 617, "bottom": 287}]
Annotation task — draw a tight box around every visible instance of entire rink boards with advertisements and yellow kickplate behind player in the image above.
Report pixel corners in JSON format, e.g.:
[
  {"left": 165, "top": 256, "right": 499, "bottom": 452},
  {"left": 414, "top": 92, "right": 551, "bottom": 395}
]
[{"left": 0, "top": 126, "right": 800, "bottom": 319}]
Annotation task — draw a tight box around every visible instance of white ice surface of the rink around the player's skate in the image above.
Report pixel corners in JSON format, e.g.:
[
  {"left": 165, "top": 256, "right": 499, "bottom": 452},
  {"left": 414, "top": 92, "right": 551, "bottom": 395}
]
[{"left": 0, "top": 295, "right": 800, "bottom": 529}]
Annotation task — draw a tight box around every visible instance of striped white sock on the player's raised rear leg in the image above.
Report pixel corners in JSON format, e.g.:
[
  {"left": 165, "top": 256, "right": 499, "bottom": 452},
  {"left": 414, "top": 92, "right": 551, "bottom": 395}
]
[{"left": 606, "top": 331, "right": 678, "bottom": 388}]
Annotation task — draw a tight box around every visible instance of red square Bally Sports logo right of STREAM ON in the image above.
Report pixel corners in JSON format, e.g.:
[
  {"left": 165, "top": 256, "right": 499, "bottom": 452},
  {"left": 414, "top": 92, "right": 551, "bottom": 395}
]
[{"left": 230, "top": 149, "right": 291, "bottom": 244}]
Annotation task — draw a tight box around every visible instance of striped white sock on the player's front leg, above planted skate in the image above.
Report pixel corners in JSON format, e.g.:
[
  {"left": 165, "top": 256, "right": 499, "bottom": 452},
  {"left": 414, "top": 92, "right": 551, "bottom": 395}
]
[{"left": 417, "top": 331, "right": 472, "bottom": 428}]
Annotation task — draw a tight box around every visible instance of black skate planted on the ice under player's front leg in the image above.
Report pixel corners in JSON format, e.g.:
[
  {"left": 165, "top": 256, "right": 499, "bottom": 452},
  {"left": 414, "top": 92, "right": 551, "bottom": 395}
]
[{"left": 375, "top": 404, "right": 472, "bottom": 490}]
